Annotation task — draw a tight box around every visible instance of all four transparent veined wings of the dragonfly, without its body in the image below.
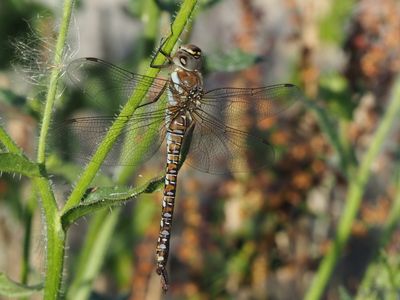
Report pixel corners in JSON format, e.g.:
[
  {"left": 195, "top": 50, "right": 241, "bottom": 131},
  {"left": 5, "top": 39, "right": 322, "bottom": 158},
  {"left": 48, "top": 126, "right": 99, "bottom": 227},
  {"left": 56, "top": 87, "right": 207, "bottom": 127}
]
[{"left": 57, "top": 58, "right": 300, "bottom": 174}]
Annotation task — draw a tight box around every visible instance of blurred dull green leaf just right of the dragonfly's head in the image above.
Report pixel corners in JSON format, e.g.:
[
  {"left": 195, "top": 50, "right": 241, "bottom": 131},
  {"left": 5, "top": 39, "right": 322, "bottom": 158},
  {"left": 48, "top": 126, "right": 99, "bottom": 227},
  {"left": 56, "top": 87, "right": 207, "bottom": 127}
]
[{"left": 205, "top": 48, "right": 261, "bottom": 72}]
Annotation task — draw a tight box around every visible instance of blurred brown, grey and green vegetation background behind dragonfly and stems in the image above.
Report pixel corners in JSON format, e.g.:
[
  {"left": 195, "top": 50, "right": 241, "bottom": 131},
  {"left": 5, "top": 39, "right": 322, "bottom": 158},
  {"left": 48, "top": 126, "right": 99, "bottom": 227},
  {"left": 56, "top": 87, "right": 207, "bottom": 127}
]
[{"left": 0, "top": 0, "right": 400, "bottom": 299}]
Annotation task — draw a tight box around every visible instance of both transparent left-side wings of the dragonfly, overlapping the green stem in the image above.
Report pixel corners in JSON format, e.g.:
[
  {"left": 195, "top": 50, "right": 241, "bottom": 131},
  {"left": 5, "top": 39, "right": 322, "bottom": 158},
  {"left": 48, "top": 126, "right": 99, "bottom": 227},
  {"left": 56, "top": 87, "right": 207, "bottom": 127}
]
[{"left": 51, "top": 57, "right": 168, "bottom": 166}]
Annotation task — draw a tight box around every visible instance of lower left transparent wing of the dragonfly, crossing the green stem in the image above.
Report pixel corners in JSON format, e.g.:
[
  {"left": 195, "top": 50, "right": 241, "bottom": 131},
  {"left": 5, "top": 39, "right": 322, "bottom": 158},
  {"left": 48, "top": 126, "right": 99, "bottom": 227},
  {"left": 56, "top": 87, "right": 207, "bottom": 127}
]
[{"left": 51, "top": 99, "right": 165, "bottom": 166}]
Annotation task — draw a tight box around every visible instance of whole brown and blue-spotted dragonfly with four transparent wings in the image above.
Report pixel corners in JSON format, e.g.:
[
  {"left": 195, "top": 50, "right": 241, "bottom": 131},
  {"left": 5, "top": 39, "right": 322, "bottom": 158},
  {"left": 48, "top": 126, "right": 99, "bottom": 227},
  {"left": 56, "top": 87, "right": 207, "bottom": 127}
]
[{"left": 61, "top": 44, "right": 301, "bottom": 291}]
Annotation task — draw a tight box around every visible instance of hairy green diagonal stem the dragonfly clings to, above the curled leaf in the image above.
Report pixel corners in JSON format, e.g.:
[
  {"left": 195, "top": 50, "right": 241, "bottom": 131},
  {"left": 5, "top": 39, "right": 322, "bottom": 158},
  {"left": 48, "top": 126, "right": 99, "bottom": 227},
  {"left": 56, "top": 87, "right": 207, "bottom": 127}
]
[{"left": 63, "top": 0, "right": 197, "bottom": 211}]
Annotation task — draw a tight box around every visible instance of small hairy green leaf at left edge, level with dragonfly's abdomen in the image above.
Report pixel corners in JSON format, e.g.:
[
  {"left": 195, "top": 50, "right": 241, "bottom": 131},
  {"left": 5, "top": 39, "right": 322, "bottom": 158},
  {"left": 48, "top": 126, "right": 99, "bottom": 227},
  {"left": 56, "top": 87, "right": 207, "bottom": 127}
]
[{"left": 0, "top": 153, "right": 42, "bottom": 177}]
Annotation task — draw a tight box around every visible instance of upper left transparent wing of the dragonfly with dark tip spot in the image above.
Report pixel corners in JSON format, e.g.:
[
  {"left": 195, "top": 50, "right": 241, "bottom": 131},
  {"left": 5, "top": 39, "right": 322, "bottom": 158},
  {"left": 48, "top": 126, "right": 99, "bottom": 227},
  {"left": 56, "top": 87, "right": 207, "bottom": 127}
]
[{"left": 67, "top": 57, "right": 168, "bottom": 109}]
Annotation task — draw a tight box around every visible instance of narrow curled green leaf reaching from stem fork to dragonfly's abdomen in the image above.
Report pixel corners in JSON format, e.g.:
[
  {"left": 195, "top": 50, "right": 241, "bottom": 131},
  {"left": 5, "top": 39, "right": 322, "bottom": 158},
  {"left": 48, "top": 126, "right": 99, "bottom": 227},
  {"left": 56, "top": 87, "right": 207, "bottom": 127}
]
[{"left": 61, "top": 177, "right": 164, "bottom": 229}]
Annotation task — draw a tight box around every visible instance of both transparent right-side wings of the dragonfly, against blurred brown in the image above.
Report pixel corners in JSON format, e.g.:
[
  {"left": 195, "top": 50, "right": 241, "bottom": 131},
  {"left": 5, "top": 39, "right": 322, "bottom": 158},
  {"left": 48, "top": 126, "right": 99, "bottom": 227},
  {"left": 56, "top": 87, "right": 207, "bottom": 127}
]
[{"left": 187, "top": 84, "right": 301, "bottom": 174}]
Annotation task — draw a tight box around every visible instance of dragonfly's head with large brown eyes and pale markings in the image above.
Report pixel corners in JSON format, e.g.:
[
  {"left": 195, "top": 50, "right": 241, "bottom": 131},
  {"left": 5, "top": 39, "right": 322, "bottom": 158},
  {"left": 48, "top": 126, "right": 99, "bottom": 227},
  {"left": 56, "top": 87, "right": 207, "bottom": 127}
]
[{"left": 172, "top": 44, "right": 202, "bottom": 71}]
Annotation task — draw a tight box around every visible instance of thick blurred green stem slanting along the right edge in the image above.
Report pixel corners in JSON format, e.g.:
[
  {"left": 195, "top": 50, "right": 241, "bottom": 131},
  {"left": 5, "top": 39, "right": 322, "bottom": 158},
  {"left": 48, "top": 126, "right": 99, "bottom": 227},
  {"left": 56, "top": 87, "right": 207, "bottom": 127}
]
[{"left": 305, "top": 78, "right": 400, "bottom": 300}]
